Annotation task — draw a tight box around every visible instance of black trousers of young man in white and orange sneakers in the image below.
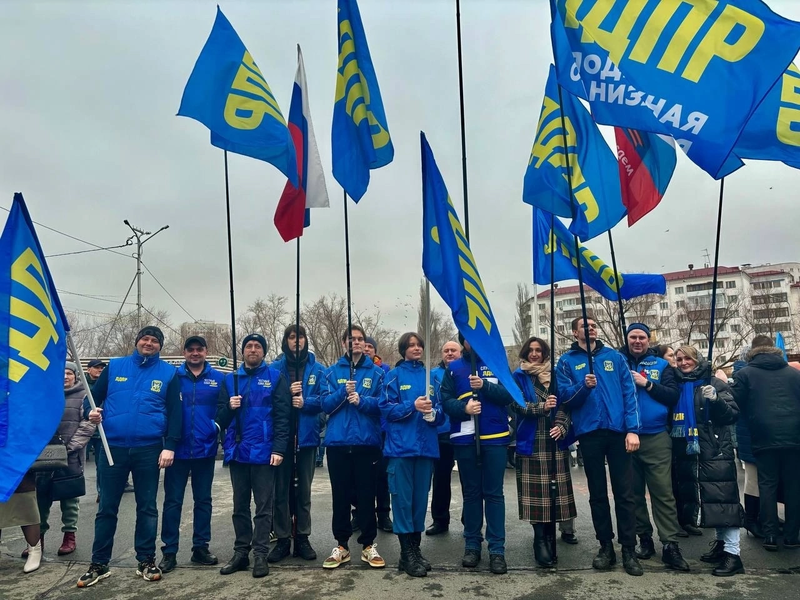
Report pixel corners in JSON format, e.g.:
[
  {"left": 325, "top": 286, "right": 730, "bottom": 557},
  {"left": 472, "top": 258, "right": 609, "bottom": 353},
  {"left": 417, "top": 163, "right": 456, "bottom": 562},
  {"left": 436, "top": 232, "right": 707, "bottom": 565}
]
[{"left": 328, "top": 446, "right": 383, "bottom": 548}]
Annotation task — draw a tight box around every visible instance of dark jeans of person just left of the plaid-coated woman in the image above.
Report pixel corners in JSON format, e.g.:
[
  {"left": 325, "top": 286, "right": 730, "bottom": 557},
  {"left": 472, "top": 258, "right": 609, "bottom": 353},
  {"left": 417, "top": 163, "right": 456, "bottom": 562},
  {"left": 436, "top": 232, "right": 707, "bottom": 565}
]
[{"left": 454, "top": 444, "right": 507, "bottom": 554}]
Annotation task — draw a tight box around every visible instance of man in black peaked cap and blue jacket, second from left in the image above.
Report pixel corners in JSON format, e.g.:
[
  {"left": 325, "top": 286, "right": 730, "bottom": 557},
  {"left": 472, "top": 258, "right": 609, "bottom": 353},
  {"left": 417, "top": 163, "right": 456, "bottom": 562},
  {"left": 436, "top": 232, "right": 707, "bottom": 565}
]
[{"left": 158, "top": 335, "right": 223, "bottom": 573}]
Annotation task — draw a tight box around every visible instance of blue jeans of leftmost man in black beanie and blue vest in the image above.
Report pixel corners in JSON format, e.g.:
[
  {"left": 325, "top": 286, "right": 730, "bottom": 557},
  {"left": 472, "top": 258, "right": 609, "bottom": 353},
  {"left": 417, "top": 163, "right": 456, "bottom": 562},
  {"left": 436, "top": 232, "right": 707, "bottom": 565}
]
[{"left": 92, "top": 444, "right": 161, "bottom": 565}]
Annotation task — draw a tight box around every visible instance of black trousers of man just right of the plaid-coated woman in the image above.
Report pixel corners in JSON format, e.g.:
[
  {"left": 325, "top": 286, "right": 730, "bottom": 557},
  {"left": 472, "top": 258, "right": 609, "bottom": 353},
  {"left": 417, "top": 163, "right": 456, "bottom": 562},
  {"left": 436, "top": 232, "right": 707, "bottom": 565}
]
[{"left": 579, "top": 429, "right": 636, "bottom": 546}]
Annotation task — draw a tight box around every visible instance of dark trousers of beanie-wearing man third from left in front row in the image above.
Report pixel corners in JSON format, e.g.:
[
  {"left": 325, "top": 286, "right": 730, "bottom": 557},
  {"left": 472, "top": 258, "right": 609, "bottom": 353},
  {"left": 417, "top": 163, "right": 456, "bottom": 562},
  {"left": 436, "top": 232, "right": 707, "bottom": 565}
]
[{"left": 228, "top": 460, "right": 275, "bottom": 556}]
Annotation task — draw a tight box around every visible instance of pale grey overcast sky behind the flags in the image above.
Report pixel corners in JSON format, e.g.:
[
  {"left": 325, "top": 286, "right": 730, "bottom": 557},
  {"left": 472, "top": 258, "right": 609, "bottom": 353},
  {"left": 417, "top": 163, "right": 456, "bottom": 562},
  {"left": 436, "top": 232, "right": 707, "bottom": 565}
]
[{"left": 0, "top": 0, "right": 800, "bottom": 343}]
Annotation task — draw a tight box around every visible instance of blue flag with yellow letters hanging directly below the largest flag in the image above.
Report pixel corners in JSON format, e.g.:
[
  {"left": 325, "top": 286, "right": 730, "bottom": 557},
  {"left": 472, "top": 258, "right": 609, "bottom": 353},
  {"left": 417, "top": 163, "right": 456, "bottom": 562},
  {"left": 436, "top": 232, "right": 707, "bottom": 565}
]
[{"left": 522, "top": 65, "right": 625, "bottom": 241}]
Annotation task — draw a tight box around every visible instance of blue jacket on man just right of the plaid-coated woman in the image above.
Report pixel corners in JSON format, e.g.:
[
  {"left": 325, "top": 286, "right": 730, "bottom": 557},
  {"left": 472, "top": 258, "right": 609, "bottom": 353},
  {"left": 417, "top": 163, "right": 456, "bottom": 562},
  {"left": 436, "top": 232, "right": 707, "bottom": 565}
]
[{"left": 556, "top": 340, "right": 641, "bottom": 437}]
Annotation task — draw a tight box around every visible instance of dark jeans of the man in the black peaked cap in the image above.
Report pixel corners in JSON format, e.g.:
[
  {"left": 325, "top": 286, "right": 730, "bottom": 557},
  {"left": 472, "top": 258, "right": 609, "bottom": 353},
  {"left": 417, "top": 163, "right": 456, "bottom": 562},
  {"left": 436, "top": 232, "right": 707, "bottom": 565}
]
[{"left": 161, "top": 456, "right": 215, "bottom": 554}]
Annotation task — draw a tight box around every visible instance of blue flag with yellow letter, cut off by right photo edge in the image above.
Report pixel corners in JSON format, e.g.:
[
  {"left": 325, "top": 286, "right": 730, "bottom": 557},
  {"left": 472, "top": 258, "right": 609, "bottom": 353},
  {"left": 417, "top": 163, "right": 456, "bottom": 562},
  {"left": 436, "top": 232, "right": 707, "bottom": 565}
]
[{"left": 733, "top": 64, "right": 800, "bottom": 169}]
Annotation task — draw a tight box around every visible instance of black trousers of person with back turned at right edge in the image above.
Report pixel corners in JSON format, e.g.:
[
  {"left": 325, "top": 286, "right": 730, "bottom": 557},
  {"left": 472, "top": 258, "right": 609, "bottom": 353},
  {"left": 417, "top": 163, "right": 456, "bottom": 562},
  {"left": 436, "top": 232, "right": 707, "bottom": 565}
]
[{"left": 756, "top": 448, "right": 800, "bottom": 541}]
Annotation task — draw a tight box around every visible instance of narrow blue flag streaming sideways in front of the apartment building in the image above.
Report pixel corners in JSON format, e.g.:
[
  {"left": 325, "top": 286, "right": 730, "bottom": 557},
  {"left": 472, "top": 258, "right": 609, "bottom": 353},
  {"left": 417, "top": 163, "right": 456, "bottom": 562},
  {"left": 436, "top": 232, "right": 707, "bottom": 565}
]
[{"left": 533, "top": 209, "right": 667, "bottom": 301}]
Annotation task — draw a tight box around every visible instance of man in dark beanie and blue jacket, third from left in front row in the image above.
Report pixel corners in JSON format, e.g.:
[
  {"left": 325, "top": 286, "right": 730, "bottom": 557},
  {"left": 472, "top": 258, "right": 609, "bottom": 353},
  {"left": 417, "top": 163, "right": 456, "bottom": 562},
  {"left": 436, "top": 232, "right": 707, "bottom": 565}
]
[{"left": 216, "top": 333, "right": 292, "bottom": 577}]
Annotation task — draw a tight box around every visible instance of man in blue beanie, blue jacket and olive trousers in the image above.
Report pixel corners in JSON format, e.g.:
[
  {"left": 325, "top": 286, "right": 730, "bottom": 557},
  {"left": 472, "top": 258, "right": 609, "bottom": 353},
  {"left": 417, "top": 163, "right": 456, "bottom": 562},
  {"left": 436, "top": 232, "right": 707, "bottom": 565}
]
[{"left": 620, "top": 323, "right": 689, "bottom": 571}]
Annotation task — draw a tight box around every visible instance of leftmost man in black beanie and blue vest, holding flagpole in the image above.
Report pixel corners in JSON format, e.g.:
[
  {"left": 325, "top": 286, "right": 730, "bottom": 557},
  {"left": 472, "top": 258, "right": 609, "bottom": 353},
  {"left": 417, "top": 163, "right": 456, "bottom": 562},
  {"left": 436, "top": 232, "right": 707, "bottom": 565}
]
[{"left": 78, "top": 325, "right": 183, "bottom": 587}]
